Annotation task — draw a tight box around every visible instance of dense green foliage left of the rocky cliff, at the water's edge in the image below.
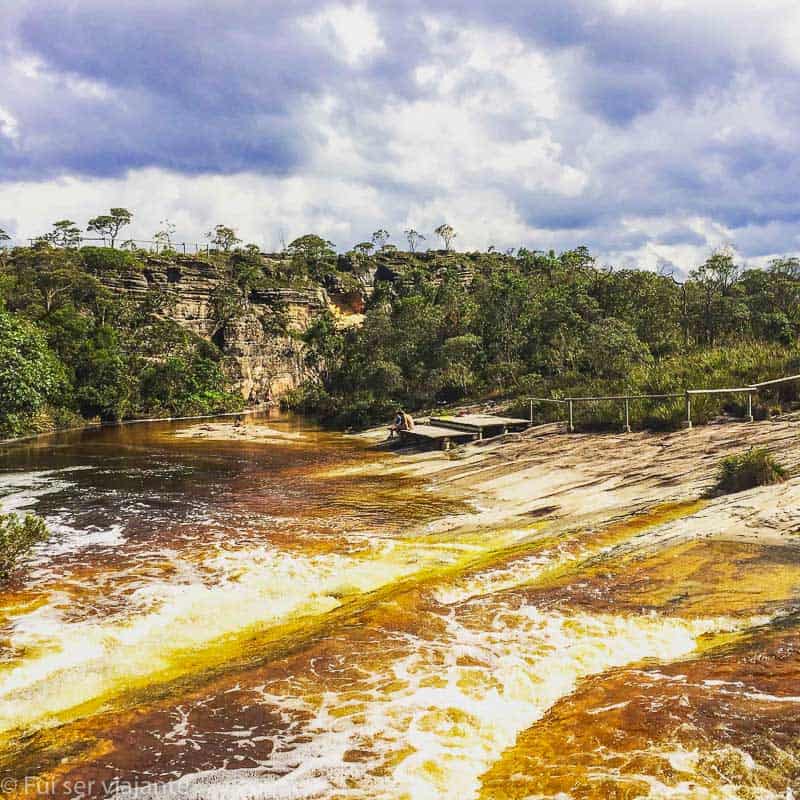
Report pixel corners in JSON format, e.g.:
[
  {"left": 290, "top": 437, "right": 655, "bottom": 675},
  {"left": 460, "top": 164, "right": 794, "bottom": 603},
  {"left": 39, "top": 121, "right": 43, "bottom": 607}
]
[{"left": 0, "top": 242, "right": 241, "bottom": 436}]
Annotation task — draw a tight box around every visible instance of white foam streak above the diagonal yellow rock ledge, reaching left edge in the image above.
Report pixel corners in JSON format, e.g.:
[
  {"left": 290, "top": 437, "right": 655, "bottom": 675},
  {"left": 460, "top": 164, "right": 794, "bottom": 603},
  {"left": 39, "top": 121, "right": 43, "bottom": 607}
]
[{"left": 0, "top": 520, "right": 536, "bottom": 731}]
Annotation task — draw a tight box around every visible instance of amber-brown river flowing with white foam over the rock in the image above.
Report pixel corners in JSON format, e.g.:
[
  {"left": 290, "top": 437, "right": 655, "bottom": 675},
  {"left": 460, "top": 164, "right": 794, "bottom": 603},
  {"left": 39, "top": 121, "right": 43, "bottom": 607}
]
[{"left": 0, "top": 418, "right": 800, "bottom": 800}]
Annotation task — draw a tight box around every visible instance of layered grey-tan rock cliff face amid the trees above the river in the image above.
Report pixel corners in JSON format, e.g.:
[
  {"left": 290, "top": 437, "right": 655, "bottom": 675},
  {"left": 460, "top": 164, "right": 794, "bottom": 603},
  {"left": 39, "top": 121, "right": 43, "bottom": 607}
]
[{"left": 104, "top": 258, "right": 332, "bottom": 403}]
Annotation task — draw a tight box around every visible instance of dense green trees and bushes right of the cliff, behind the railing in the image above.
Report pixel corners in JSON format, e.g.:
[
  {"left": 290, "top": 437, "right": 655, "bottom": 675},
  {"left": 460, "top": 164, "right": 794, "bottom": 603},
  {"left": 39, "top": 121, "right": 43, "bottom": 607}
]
[{"left": 292, "top": 248, "right": 800, "bottom": 427}]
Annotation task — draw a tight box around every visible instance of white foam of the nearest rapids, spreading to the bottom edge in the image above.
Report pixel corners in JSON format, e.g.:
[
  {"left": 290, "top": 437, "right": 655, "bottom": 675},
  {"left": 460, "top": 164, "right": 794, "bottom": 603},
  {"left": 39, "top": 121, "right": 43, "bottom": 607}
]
[{"left": 108, "top": 606, "right": 756, "bottom": 800}]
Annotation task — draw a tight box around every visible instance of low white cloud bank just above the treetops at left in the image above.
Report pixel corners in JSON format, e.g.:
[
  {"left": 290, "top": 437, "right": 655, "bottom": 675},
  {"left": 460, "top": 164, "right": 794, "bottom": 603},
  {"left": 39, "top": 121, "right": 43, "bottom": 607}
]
[{"left": 0, "top": 169, "right": 380, "bottom": 250}]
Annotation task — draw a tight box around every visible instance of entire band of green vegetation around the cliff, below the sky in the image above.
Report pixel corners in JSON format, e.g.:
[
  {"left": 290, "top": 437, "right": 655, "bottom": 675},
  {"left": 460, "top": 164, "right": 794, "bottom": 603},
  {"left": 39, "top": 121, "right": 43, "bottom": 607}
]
[{"left": 0, "top": 214, "right": 800, "bottom": 436}]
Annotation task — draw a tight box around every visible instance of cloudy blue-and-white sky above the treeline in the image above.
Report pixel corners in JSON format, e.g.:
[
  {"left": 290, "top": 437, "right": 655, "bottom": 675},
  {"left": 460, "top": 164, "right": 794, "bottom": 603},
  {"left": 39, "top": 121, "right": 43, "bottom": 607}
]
[{"left": 0, "top": 0, "right": 800, "bottom": 273}]
